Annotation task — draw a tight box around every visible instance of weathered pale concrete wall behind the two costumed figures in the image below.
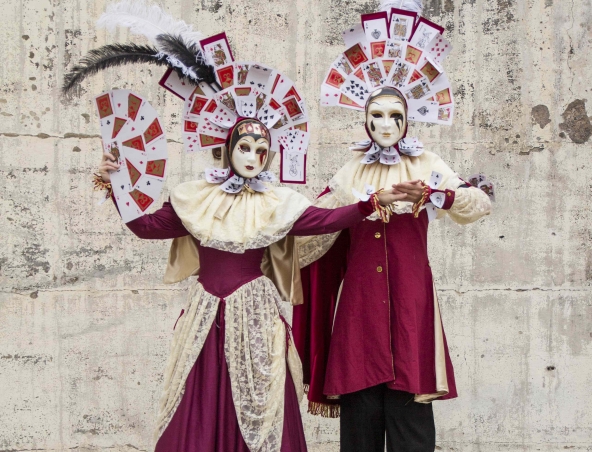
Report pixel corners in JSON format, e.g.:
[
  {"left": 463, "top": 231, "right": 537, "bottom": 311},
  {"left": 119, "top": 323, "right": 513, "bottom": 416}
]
[{"left": 0, "top": 0, "right": 592, "bottom": 452}]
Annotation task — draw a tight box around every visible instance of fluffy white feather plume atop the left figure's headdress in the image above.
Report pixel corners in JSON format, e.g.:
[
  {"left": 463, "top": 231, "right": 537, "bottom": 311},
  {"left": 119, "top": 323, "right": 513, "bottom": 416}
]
[{"left": 97, "top": 0, "right": 204, "bottom": 45}]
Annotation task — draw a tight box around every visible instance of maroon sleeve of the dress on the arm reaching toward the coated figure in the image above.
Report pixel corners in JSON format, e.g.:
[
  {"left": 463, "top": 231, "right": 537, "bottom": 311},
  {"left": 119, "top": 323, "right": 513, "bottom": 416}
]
[{"left": 290, "top": 201, "right": 373, "bottom": 236}]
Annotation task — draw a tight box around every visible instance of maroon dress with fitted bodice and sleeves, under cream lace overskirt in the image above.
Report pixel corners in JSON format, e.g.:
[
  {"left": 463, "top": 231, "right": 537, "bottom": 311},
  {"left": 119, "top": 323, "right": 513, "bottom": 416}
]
[{"left": 118, "top": 202, "right": 372, "bottom": 452}]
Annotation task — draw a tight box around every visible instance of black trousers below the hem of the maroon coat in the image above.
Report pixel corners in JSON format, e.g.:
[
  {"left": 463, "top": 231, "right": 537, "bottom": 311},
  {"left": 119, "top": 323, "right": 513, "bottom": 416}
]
[{"left": 340, "top": 385, "right": 436, "bottom": 452}]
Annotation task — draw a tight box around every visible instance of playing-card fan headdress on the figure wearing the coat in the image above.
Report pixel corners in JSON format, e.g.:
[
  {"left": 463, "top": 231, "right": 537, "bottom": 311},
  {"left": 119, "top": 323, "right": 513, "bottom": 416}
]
[{"left": 321, "top": 0, "right": 454, "bottom": 125}]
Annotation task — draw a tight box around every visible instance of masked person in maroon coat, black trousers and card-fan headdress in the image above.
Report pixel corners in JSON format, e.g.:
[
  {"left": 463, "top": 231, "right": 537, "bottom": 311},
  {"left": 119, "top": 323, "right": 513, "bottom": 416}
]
[{"left": 293, "top": 0, "right": 491, "bottom": 452}]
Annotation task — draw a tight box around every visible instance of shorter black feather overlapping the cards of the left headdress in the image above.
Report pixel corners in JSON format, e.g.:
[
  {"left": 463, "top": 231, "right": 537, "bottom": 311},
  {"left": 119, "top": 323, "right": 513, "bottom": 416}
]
[{"left": 156, "top": 34, "right": 217, "bottom": 85}]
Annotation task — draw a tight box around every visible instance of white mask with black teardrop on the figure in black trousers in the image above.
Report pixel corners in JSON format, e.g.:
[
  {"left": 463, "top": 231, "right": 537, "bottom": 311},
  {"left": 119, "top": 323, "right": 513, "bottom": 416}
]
[{"left": 366, "top": 96, "right": 407, "bottom": 148}]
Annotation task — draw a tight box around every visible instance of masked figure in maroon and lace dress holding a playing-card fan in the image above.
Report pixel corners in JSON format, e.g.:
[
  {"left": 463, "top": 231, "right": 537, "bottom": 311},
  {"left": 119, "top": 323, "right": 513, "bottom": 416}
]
[{"left": 64, "top": 2, "right": 402, "bottom": 452}]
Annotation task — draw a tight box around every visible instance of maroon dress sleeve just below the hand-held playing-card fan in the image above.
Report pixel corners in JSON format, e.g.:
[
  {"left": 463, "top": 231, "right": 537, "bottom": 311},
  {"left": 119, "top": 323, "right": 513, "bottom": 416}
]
[{"left": 113, "top": 195, "right": 189, "bottom": 240}]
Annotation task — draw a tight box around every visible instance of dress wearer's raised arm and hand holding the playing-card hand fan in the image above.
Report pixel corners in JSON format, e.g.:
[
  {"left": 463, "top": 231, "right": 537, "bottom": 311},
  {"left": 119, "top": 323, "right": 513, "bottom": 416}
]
[{"left": 99, "top": 153, "right": 189, "bottom": 240}]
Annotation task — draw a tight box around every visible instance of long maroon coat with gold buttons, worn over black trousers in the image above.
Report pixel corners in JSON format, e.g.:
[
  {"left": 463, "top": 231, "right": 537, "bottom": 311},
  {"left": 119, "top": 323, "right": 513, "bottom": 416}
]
[{"left": 294, "top": 191, "right": 457, "bottom": 416}]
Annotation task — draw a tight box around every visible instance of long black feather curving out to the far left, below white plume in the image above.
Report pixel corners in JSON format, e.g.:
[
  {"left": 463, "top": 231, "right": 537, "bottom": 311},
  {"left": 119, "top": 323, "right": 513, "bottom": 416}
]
[{"left": 62, "top": 44, "right": 169, "bottom": 95}]
